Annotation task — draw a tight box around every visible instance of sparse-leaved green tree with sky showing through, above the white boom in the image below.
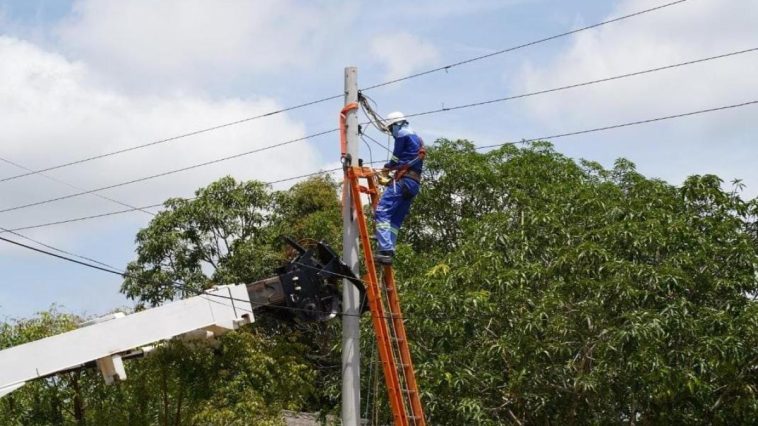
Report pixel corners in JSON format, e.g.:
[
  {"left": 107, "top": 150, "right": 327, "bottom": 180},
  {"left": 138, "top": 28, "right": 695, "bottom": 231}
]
[{"left": 122, "top": 177, "right": 274, "bottom": 305}]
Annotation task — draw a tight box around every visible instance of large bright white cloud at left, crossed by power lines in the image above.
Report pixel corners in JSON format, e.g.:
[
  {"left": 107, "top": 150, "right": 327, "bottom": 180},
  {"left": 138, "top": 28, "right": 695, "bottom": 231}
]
[{"left": 0, "top": 36, "right": 329, "bottom": 246}]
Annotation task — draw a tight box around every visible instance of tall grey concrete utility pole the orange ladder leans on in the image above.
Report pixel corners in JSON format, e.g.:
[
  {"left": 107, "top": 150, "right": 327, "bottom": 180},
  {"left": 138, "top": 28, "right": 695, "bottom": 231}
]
[{"left": 342, "top": 67, "right": 361, "bottom": 426}]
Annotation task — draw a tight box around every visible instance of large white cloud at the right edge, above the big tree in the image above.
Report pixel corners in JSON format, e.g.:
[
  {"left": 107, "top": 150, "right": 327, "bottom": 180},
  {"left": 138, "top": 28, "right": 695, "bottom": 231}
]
[{"left": 512, "top": 0, "right": 758, "bottom": 194}]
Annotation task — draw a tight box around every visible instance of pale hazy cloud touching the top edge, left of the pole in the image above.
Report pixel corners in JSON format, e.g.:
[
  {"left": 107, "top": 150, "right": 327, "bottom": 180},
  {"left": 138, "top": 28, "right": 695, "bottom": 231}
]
[{"left": 53, "top": 0, "right": 351, "bottom": 89}]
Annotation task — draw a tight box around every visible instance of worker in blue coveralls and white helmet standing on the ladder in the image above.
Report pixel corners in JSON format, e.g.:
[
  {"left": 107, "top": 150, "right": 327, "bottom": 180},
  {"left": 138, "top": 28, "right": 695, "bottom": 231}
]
[{"left": 375, "top": 112, "right": 426, "bottom": 265}]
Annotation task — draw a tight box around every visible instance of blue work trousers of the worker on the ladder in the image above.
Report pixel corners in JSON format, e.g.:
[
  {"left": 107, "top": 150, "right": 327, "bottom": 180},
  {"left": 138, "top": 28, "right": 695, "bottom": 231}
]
[{"left": 375, "top": 178, "right": 421, "bottom": 252}]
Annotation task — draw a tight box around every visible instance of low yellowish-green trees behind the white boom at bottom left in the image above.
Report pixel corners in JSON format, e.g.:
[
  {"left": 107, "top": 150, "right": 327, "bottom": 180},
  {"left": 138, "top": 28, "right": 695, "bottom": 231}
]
[{"left": 0, "top": 311, "right": 316, "bottom": 426}]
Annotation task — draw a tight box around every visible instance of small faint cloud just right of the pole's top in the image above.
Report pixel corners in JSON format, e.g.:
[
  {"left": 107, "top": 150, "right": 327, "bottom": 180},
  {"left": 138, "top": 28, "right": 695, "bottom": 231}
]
[{"left": 371, "top": 32, "right": 440, "bottom": 80}]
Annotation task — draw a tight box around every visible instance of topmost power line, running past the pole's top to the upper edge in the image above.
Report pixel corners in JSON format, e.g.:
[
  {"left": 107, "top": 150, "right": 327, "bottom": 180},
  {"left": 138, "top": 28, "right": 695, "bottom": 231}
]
[{"left": 0, "top": 0, "right": 687, "bottom": 183}]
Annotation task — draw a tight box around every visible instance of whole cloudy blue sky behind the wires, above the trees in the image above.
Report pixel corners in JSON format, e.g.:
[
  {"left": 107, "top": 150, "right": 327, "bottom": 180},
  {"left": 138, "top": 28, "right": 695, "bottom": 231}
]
[{"left": 0, "top": 0, "right": 758, "bottom": 318}]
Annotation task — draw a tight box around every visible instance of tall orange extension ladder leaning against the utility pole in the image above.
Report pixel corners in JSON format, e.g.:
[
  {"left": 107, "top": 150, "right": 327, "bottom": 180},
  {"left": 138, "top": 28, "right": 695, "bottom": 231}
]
[{"left": 345, "top": 166, "right": 426, "bottom": 426}]
